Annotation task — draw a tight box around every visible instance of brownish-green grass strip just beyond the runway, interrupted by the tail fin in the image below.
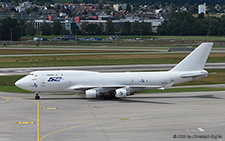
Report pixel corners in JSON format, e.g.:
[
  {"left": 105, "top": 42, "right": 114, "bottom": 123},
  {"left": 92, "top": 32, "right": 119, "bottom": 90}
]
[{"left": 0, "top": 53, "right": 225, "bottom": 68}]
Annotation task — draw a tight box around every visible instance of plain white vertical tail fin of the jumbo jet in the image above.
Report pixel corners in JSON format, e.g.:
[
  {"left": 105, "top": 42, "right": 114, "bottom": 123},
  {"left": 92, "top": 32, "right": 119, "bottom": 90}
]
[{"left": 170, "top": 42, "right": 213, "bottom": 71}]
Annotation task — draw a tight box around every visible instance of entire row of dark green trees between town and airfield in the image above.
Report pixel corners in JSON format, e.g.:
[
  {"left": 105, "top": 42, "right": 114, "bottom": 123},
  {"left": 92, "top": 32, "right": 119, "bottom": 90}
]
[{"left": 0, "top": 12, "right": 225, "bottom": 41}]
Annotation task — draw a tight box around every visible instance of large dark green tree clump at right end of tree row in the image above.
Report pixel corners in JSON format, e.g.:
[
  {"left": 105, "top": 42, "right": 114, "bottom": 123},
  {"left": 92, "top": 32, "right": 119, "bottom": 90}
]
[{"left": 157, "top": 12, "right": 225, "bottom": 36}]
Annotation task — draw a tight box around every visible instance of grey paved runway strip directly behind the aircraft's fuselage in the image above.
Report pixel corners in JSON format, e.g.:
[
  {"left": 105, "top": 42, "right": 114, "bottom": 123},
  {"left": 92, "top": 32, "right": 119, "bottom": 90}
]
[{"left": 0, "top": 63, "right": 225, "bottom": 76}]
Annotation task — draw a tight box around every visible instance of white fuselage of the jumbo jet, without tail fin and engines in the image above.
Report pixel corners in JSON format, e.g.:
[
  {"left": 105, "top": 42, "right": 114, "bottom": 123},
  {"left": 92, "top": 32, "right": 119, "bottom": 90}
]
[{"left": 16, "top": 70, "right": 206, "bottom": 92}]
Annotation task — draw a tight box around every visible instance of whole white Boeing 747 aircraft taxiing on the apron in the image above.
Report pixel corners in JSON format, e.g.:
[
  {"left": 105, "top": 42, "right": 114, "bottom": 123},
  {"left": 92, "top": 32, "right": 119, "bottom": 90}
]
[{"left": 15, "top": 43, "right": 213, "bottom": 99}]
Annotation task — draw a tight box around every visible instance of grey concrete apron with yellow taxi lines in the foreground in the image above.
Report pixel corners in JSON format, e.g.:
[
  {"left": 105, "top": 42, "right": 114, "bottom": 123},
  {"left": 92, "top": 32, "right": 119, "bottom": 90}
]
[{"left": 0, "top": 91, "right": 225, "bottom": 141}]
